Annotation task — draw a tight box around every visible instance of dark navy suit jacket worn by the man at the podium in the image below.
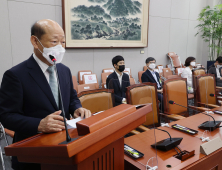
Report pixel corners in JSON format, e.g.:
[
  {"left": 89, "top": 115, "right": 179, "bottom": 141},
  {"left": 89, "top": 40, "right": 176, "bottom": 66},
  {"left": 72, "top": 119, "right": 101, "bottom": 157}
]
[{"left": 0, "top": 56, "right": 82, "bottom": 169}]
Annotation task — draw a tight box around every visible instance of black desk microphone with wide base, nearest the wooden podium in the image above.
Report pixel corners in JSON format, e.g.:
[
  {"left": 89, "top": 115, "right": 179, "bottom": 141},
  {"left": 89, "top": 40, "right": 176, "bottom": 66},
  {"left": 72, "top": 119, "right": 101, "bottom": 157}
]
[{"left": 151, "top": 128, "right": 183, "bottom": 151}]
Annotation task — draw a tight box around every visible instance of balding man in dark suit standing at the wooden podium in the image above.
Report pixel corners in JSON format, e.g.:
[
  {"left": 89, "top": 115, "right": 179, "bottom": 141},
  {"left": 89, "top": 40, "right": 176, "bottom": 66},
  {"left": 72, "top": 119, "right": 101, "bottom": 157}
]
[{"left": 0, "top": 20, "right": 91, "bottom": 170}]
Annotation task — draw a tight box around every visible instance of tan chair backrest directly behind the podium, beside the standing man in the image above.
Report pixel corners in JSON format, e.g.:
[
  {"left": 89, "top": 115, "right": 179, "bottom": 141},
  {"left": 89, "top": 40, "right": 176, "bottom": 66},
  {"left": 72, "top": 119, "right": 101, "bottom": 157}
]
[{"left": 78, "top": 89, "right": 114, "bottom": 113}]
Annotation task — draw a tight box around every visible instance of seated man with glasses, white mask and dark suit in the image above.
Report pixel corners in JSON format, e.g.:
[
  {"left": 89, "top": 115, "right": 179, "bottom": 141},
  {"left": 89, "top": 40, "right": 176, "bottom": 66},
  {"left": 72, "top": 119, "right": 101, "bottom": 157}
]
[{"left": 141, "top": 57, "right": 164, "bottom": 112}]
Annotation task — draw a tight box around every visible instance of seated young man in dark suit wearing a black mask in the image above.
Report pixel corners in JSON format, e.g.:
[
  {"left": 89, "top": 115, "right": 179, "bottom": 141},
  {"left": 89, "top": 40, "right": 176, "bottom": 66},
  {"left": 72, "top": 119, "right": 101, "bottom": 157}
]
[{"left": 106, "top": 55, "right": 130, "bottom": 106}]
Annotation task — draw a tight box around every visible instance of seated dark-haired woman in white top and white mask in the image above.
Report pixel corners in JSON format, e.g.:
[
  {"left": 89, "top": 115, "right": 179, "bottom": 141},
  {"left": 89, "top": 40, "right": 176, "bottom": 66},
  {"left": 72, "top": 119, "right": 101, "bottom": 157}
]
[{"left": 181, "top": 57, "right": 196, "bottom": 93}]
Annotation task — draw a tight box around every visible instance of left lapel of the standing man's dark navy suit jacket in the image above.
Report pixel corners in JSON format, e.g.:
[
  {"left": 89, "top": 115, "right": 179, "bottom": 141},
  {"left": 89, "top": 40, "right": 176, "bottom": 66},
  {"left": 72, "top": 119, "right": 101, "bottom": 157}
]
[{"left": 28, "top": 56, "right": 58, "bottom": 110}]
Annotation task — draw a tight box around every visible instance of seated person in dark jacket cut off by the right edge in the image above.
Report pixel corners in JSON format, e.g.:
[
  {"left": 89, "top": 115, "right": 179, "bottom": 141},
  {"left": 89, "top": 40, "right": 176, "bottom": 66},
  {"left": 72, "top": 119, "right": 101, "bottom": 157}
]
[{"left": 208, "top": 56, "right": 222, "bottom": 87}]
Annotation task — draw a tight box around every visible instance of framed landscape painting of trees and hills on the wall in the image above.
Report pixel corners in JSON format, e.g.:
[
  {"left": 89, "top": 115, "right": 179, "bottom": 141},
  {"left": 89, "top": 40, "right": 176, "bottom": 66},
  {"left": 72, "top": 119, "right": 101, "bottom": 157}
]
[{"left": 62, "top": 0, "right": 149, "bottom": 48}]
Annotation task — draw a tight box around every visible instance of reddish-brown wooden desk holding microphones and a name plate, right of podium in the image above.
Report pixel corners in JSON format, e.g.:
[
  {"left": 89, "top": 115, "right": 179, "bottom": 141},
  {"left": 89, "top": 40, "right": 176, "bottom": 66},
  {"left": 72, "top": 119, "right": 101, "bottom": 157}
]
[{"left": 124, "top": 107, "right": 222, "bottom": 170}]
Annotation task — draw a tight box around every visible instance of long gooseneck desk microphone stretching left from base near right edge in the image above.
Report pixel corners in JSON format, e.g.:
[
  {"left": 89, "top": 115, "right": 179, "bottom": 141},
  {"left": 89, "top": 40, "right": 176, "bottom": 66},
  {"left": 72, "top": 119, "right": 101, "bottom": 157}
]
[{"left": 169, "top": 100, "right": 221, "bottom": 131}]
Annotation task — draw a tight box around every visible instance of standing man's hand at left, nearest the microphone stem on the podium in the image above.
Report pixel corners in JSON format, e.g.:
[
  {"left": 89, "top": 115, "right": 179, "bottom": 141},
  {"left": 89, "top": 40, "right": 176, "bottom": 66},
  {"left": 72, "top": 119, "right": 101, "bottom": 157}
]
[{"left": 38, "top": 110, "right": 65, "bottom": 133}]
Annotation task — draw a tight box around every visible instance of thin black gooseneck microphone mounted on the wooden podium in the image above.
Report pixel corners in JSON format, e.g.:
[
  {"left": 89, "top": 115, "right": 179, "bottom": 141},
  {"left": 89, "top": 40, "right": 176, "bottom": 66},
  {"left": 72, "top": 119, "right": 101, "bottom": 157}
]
[{"left": 49, "top": 55, "right": 75, "bottom": 144}]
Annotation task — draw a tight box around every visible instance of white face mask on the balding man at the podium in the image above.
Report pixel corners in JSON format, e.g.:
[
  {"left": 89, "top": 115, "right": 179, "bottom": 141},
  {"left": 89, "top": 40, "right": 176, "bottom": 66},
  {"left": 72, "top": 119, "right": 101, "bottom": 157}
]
[{"left": 36, "top": 37, "right": 66, "bottom": 64}]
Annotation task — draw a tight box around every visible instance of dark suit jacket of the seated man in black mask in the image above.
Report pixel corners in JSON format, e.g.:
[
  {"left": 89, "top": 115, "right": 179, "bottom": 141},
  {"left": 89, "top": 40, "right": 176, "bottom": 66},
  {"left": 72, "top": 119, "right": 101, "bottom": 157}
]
[{"left": 106, "top": 71, "right": 130, "bottom": 106}]
